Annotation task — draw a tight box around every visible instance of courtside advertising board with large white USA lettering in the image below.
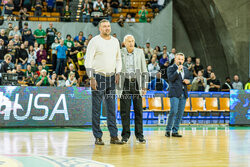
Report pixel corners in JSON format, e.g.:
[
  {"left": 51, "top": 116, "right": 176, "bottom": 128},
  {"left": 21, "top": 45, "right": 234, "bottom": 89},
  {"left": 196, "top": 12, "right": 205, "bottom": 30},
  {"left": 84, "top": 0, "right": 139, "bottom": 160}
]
[{"left": 0, "top": 86, "right": 92, "bottom": 127}]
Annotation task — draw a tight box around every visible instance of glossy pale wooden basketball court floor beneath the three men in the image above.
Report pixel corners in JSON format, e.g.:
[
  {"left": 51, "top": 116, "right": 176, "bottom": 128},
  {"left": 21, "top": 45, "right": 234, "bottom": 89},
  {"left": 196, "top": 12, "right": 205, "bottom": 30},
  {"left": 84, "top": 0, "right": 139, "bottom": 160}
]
[{"left": 0, "top": 126, "right": 250, "bottom": 167}]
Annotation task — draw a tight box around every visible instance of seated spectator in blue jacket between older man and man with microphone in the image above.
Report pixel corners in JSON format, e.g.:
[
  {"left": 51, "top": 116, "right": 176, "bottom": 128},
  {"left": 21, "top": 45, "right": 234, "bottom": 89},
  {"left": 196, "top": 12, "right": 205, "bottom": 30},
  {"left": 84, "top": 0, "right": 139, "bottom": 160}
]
[{"left": 148, "top": 72, "right": 168, "bottom": 91}]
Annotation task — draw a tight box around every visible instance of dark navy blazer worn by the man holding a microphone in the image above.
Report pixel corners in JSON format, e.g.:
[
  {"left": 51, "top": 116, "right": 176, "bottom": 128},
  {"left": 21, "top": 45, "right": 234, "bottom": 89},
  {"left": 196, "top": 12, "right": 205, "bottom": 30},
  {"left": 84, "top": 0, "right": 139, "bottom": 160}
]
[{"left": 167, "top": 64, "right": 189, "bottom": 98}]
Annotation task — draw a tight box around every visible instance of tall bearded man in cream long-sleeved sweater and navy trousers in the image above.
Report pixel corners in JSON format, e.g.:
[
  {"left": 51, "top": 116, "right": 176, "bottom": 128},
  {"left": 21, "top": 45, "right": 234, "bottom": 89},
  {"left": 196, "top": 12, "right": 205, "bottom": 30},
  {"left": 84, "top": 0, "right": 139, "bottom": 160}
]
[{"left": 85, "top": 20, "right": 123, "bottom": 145}]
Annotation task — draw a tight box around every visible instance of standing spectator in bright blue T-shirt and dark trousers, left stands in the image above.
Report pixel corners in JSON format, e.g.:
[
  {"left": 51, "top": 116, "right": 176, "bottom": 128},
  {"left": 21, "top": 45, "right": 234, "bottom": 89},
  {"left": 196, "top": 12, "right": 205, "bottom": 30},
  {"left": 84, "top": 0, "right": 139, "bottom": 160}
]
[{"left": 56, "top": 40, "right": 68, "bottom": 75}]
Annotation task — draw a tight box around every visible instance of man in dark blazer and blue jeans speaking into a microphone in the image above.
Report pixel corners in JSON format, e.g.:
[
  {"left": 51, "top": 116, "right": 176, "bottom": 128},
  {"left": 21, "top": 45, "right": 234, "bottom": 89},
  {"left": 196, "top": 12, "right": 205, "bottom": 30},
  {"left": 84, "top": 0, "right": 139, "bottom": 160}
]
[{"left": 165, "top": 53, "right": 190, "bottom": 137}]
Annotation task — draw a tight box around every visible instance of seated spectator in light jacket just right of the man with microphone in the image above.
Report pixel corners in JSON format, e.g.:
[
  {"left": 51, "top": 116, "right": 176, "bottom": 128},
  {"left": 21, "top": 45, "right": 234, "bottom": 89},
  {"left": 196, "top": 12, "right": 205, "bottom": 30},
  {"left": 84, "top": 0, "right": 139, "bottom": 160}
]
[{"left": 191, "top": 71, "right": 207, "bottom": 92}]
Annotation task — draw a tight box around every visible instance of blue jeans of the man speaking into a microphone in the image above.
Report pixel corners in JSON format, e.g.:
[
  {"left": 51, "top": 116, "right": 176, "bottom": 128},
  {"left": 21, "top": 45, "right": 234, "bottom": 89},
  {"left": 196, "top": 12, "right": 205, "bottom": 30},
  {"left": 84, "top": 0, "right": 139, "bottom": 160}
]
[{"left": 166, "top": 92, "right": 186, "bottom": 133}]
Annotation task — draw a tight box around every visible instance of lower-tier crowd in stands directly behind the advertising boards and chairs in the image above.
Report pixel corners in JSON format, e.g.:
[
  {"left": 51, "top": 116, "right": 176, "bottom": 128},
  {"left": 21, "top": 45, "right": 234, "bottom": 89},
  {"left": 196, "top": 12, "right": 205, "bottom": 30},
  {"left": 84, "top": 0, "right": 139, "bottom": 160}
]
[{"left": 0, "top": 22, "right": 250, "bottom": 92}]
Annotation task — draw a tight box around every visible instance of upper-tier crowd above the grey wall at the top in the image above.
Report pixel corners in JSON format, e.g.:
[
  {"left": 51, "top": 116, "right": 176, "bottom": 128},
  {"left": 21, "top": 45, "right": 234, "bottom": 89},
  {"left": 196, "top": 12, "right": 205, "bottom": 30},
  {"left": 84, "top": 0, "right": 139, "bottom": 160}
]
[{"left": 0, "top": 0, "right": 169, "bottom": 22}]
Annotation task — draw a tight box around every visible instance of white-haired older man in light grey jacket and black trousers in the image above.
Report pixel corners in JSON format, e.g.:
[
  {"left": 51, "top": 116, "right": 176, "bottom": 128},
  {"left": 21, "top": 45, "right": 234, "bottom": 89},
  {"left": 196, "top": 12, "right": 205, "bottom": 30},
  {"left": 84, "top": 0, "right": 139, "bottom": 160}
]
[{"left": 117, "top": 35, "right": 148, "bottom": 143}]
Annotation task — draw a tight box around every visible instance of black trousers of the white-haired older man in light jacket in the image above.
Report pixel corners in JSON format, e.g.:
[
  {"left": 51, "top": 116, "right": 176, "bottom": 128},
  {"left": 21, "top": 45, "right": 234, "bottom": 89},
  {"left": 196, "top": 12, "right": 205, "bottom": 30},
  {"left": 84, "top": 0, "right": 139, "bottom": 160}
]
[{"left": 120, "top": 79, "right": 143, "bottom": 138}]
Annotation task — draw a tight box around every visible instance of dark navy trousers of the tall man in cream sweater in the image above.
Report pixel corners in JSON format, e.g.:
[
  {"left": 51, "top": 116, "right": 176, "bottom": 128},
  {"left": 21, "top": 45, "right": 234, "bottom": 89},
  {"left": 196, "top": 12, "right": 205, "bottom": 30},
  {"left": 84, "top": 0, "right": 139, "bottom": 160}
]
[{"left": 92, "top": 74, "right": 118, "bottom": 138}]
